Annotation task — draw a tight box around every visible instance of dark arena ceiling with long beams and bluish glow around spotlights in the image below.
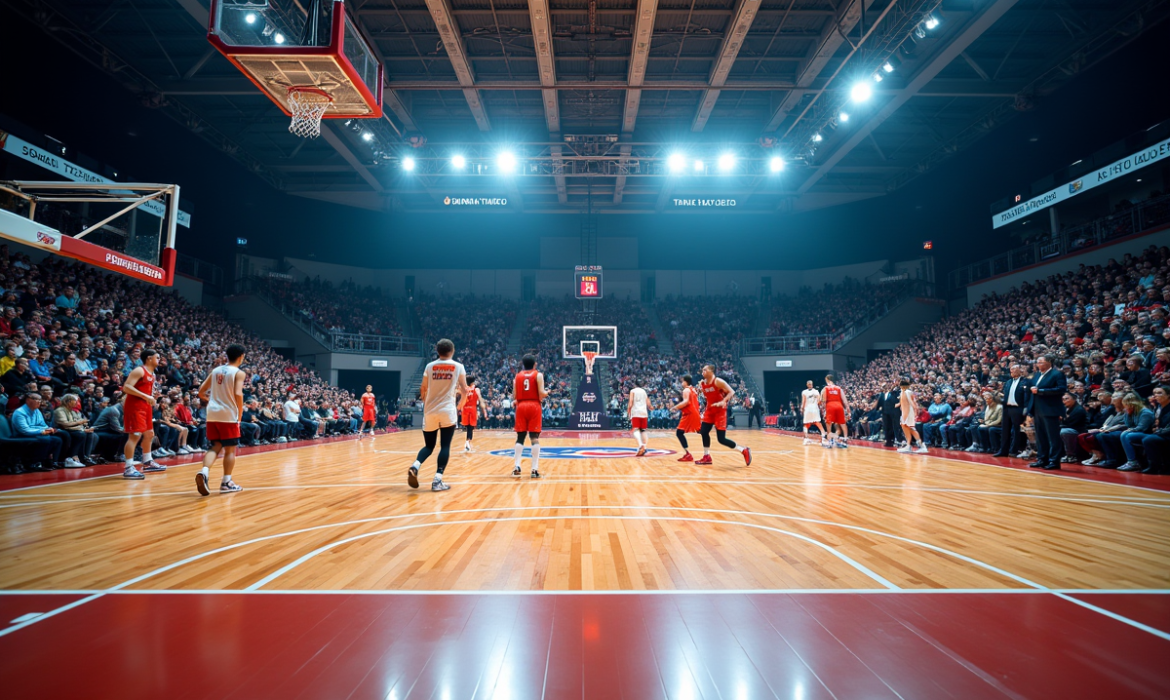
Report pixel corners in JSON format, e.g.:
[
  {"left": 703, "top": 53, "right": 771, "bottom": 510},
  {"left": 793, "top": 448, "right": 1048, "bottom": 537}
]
[{"left": 0, "top": 0, "right": 1170, "bottom": 213}]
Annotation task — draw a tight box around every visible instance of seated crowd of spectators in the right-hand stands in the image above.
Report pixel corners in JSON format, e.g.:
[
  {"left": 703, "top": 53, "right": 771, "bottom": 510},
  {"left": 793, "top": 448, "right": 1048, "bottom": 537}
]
[{"left": 782, "top": 246, "right": 1170, "bottom": 472}]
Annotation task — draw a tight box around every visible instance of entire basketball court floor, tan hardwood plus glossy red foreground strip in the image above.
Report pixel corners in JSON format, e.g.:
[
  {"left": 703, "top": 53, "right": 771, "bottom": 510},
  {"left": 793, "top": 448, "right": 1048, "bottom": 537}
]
[{"left": 0, "top": 431, "right": 1170, "bottom": 698}]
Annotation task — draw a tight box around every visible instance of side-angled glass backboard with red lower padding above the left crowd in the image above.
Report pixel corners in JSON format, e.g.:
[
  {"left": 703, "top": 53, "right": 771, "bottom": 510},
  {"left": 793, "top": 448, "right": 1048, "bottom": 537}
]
[{"left": 0, "top": 180, "right": 180, "bottom": 287}]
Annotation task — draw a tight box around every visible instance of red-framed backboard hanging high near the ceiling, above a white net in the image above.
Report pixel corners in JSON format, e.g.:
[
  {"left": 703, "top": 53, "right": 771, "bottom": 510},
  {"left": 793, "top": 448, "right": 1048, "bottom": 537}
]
[{"left": 207, "top": 0, "right": 383, "bottom": 119}]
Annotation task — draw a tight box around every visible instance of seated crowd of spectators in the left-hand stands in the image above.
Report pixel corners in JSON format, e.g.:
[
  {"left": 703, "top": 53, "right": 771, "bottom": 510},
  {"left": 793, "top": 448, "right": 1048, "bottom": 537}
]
[{"left": 0, "top": 246, "right": 386, "bottom": 471}]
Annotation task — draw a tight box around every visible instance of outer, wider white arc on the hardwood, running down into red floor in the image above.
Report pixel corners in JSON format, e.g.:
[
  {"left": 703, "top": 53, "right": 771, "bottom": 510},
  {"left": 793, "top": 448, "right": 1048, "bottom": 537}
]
[{"left": 0, "top": 506, "right": 1170, "bottom": 640}]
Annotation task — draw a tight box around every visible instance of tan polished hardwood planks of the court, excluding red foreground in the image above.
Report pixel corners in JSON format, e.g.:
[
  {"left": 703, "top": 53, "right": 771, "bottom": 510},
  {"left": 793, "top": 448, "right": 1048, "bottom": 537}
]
[{"left": 0, "top": 431, "right": 1170, "bottom": 591}]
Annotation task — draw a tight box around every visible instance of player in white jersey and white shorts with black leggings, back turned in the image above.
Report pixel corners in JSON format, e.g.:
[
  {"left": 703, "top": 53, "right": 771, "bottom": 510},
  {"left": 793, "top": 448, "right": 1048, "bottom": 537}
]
[{"left": 406, "top": 338, "right": 467, "bottom": 490}]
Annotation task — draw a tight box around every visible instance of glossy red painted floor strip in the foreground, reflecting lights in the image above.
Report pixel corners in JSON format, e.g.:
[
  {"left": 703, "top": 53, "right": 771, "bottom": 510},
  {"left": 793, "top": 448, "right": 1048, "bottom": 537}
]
[{"left": 0, "top": 592, "right": 1170, "bottom": 700}]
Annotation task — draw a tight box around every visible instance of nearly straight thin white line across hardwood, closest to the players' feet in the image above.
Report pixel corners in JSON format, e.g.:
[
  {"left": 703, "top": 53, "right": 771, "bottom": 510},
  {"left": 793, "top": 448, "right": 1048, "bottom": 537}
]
[{"left": 0, "top": 475, "right": 1170, "bottom": 509}]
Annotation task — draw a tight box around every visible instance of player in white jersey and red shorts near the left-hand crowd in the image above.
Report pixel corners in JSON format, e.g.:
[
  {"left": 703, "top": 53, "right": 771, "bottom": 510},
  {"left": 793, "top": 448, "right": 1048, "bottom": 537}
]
[{"left": 195, "top": 344, "right": 247, "bottom": 496}]
